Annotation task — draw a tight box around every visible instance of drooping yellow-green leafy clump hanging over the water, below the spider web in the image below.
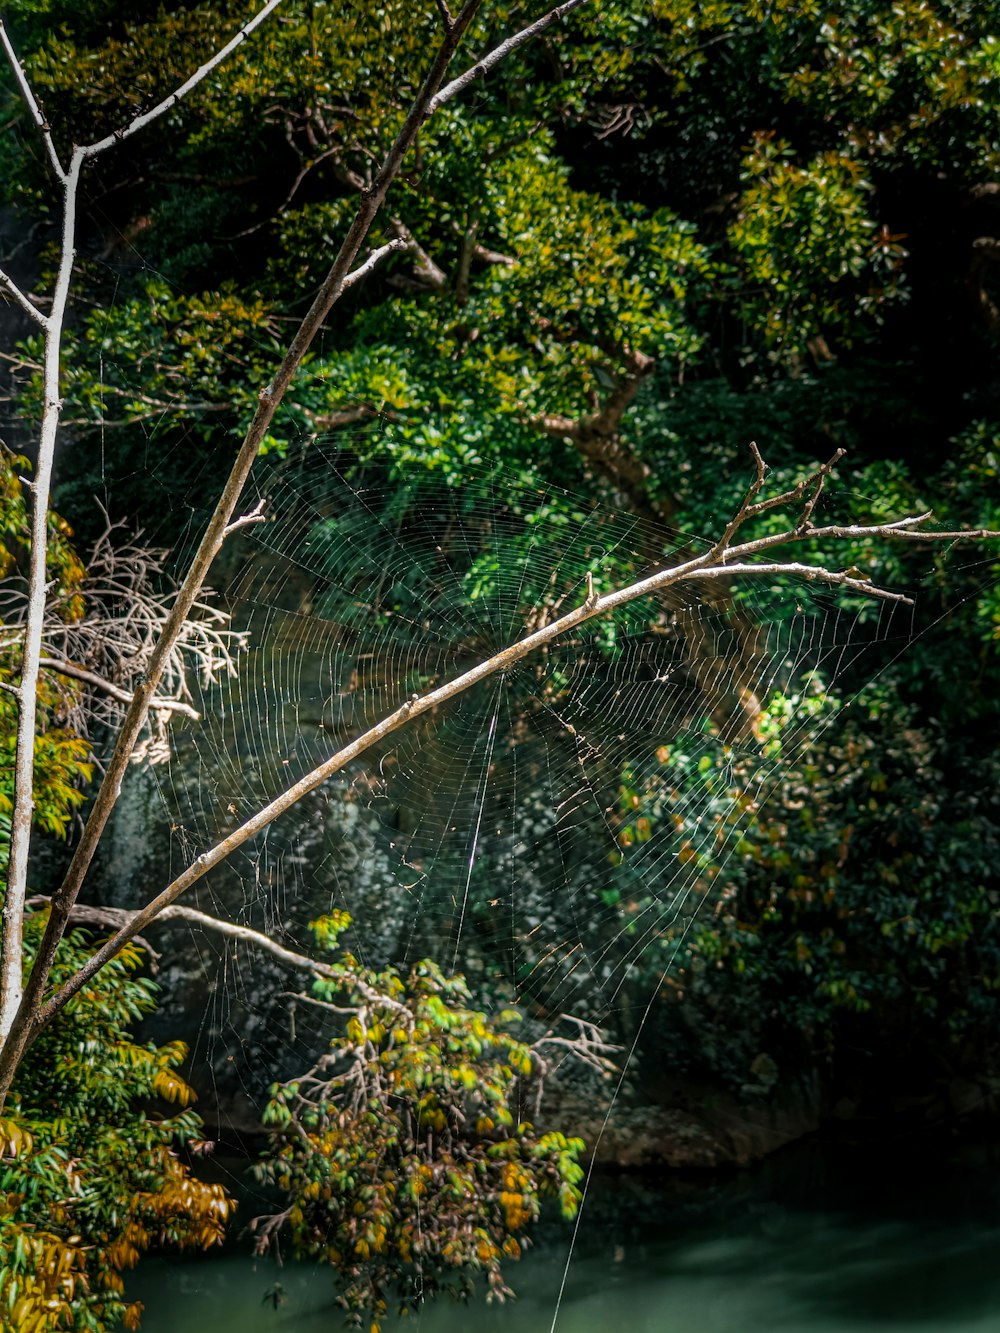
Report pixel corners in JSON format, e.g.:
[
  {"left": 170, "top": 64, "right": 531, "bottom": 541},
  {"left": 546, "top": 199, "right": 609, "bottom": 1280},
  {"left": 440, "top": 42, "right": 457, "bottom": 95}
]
[{"left": 256, "top": 913, "right": 583, "bottom": 1330}]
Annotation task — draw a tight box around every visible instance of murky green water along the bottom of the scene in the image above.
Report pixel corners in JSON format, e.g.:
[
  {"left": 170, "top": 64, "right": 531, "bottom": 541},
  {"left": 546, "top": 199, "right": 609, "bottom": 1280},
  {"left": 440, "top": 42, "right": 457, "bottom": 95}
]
[{"left": 129, "top": 1140, "right": 1000, "bottom": 1333}]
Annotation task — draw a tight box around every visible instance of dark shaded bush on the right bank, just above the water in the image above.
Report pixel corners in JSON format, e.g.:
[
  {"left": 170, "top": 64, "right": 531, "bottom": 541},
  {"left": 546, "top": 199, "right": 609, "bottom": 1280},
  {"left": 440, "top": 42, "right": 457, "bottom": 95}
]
[{"left": 620, "top": 682, "right": 1000, "bottom": 1096}]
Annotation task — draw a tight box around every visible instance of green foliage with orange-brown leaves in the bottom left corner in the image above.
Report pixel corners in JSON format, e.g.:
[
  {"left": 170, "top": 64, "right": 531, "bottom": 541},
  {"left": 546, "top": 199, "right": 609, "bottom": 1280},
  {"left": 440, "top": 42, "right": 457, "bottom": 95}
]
[{"left": 0, "top": 916, "right": 233, "bottom": 1333}]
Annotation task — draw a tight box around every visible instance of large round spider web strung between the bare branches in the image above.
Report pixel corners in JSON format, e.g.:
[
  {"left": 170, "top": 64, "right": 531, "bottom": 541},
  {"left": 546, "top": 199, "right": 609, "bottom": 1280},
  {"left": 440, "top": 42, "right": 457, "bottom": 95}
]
[{"left": 98, "top": 424, "right": 909, "bottom": 1125}]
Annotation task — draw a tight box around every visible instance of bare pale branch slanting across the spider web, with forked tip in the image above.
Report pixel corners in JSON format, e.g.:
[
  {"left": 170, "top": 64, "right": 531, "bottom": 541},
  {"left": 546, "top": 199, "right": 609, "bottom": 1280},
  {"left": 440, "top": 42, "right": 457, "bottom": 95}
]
[{"left": 32, "top": 445, "right": 1000, "bottom": 1033}]
